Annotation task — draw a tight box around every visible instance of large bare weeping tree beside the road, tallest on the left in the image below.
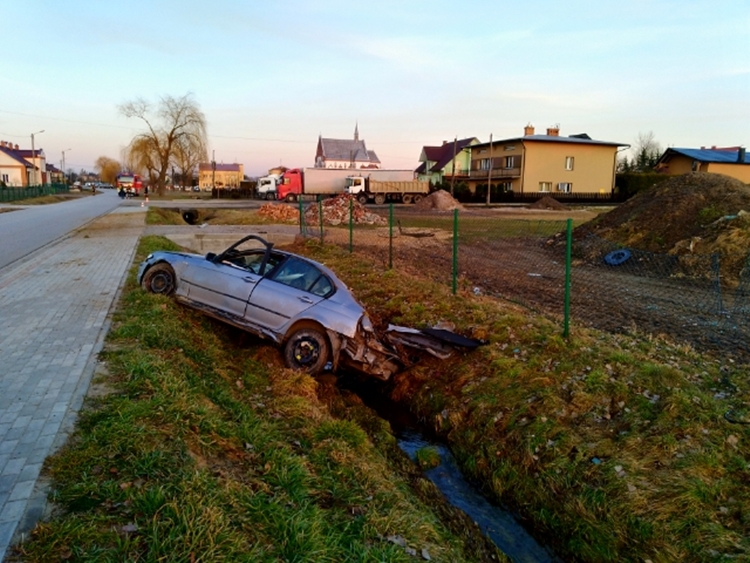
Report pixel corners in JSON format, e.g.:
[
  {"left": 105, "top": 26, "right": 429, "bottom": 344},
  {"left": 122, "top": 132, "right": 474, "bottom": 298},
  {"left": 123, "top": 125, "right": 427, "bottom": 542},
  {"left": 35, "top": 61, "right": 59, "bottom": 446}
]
[{"left": 118, "top": 94, "right": 207, "bottom": 194}]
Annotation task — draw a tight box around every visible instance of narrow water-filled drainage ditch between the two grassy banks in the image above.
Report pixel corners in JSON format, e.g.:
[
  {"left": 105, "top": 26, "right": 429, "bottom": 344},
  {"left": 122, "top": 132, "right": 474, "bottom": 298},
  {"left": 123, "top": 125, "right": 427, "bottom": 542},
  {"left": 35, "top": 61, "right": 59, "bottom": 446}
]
[{"left": 338, "top": 375, "right": 562, "bottom": 563}]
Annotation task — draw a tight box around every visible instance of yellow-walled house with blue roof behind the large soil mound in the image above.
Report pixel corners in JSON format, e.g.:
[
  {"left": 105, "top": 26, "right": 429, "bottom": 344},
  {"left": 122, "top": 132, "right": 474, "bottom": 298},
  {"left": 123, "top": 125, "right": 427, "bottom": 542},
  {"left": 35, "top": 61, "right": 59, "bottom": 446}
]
[{"left": 654, "top": 147, "right": 750, "bottom": 184}]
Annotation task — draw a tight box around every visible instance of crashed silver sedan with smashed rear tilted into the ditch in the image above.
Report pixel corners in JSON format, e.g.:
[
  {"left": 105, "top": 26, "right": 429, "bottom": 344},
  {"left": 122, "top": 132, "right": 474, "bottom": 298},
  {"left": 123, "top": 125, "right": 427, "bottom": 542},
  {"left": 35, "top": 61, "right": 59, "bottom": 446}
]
[{"left": 138, "top": 235, "right": 472, "bottom": 380}]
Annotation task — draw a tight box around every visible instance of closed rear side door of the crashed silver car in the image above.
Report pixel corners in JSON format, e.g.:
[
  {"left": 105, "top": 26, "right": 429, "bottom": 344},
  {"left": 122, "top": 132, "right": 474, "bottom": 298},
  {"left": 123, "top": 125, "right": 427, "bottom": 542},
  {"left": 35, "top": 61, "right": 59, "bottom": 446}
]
[{"left": 245, "top": 256, "right": 333, "bottom": 332}]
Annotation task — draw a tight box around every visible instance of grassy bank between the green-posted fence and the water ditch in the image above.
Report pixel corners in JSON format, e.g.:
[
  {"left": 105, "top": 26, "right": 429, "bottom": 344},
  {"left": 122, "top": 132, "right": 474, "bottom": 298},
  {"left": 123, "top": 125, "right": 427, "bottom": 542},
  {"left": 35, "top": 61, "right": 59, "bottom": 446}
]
[{"left": 296, "top": 242, "right": 750, "bottom": 563}]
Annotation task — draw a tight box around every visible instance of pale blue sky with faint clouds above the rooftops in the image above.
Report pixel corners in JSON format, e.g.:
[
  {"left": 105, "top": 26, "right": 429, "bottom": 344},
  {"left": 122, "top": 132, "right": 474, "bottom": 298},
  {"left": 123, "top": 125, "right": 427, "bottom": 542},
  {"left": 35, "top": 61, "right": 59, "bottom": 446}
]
[{"left": 0, "top": 0, "right": 750, "bottom": 176}]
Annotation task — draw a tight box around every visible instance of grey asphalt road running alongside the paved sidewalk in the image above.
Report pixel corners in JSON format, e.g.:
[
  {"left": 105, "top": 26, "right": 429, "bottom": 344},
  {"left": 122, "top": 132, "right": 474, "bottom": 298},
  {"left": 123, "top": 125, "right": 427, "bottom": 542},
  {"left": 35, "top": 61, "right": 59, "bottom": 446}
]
[{"left": 0, "top": 190, "right": 121, "bottom": 268}]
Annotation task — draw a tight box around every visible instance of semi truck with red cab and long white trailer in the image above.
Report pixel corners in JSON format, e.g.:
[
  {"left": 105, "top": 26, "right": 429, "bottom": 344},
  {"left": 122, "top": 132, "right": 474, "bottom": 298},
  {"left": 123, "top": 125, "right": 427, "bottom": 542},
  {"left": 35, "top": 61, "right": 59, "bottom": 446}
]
[{"left": 276, "top": 168, "right": 414, "bottom": 202}]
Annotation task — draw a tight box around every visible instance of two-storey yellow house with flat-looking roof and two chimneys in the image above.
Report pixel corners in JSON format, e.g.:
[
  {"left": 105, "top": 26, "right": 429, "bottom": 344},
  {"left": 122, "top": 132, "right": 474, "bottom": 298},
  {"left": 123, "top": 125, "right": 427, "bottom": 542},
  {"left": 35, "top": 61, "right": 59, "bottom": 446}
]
[{"left": 468, "top": 125, "right": 629, "bottom": 197}]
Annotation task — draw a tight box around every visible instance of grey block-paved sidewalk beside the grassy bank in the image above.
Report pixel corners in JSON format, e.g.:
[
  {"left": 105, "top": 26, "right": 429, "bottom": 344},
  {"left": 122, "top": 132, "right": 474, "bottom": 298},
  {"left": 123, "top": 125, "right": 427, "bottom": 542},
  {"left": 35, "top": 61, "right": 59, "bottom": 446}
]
[{"left": 0, "top": 207, "right": 146, "bottom": 561}]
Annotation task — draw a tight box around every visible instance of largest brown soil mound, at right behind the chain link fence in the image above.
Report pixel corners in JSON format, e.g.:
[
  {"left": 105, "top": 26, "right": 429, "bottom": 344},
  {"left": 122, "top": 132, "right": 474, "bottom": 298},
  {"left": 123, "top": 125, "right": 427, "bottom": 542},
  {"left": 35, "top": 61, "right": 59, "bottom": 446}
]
[{"left": 576, "top": 172, "right": 750, "bottom": 272}]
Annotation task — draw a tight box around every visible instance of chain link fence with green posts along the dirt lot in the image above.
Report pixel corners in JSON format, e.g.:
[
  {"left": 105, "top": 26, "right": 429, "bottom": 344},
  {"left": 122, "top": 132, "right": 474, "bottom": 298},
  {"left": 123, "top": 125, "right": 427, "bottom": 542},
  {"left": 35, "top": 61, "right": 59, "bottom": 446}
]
[{"left": 300, "top": 198, "right": 750, "bottom": 361}]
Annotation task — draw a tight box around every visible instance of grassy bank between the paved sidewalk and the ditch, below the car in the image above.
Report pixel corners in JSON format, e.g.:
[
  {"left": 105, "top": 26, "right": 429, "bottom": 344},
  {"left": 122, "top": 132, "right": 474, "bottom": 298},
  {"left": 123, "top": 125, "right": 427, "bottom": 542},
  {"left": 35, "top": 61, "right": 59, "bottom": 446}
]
[{"left": 13, "top": 237, "right": 502, "bottom": 562}]
